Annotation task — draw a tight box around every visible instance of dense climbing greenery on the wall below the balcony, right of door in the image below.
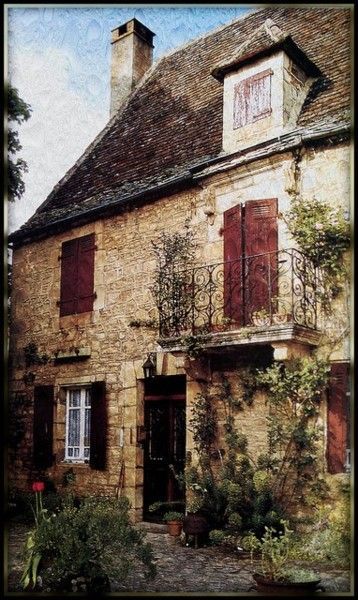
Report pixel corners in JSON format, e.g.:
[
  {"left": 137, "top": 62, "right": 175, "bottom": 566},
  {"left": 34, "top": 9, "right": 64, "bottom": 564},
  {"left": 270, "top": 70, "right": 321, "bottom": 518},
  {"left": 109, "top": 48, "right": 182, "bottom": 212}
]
[{"left": 187, "top": 357, "right": 329, "bottom": 539}]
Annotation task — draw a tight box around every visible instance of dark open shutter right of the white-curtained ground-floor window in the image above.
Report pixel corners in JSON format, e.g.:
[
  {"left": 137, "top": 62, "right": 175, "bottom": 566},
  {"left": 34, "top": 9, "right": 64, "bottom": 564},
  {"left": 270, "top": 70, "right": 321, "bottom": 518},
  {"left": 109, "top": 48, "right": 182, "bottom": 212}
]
[{"left": 90, "top": 381, "right": 107, "bottom": 471}]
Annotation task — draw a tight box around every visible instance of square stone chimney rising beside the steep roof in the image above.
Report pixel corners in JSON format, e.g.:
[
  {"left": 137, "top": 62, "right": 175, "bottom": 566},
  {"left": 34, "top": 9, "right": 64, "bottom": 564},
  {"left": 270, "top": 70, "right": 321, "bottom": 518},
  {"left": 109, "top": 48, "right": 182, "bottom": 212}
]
[{"left": 110, "top": 19, "right": 155, "bottom": 117}]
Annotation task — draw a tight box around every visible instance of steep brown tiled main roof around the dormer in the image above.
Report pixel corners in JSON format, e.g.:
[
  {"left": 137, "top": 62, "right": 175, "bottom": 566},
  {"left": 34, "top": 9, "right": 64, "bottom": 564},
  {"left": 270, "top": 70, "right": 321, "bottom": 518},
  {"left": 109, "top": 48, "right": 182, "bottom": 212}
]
[{"left": 10, "top": 7, "right": 352, "bottom": 241}]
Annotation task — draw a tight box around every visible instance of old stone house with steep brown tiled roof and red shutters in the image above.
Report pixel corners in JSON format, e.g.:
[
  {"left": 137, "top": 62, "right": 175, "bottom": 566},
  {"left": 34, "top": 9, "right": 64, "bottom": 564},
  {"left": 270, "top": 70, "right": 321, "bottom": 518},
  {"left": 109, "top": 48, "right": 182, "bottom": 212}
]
[{"left": 9, "top": 8, "right": 351, "bottom": 520}]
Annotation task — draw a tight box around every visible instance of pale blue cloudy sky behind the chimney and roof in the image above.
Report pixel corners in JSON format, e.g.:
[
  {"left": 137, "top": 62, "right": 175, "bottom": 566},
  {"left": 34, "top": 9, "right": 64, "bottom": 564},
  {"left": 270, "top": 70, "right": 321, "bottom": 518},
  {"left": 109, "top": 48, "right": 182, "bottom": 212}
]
[{"left": 5, "top": 4, "right": 262, "bottom": 233}]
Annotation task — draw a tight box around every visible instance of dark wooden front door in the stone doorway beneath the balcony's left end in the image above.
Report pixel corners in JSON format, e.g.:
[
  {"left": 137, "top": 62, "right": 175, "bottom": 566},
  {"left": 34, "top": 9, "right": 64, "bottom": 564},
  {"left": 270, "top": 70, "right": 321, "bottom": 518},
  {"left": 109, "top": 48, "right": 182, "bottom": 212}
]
[{"left": 143, "top": 377, "right": 186, "bottom": 519}]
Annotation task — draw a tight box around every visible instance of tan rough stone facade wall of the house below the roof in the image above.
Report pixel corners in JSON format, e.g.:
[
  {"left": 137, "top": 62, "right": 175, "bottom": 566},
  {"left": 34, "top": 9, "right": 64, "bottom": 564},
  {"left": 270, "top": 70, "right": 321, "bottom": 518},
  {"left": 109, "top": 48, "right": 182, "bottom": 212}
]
[{"left": 9, "top": 139, "right": 349, "bottom": 519}]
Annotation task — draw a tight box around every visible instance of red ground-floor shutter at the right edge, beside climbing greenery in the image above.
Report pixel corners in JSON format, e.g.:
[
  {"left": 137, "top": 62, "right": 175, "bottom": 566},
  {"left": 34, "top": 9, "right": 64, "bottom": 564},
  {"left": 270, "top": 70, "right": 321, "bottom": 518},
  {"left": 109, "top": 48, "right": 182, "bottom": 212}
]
[{"left": 327, "top": 363, "right": 349, "bottom": 473}]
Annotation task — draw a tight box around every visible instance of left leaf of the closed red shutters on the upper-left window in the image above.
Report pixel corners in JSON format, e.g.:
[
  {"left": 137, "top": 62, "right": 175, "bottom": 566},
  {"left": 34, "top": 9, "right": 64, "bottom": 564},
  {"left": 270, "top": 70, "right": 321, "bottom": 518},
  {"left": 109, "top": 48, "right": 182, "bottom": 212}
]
[{"left": 60, "top": 239, "right": 78, "bottom": 317}]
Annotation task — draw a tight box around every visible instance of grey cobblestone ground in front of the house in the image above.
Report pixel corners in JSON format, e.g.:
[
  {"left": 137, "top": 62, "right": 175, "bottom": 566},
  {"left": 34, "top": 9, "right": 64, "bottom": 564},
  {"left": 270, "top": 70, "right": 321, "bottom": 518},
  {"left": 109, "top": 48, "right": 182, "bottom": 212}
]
[{"left": 7, "top": 524, "right": 350, "bottom": 596}]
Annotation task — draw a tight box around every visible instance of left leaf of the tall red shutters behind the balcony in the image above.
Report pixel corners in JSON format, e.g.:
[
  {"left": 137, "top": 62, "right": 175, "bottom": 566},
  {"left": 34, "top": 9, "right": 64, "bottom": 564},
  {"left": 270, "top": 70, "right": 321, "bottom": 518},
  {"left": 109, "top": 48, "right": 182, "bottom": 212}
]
[{"left": 224, "top": 204, "right": 243, "bottom": 325}]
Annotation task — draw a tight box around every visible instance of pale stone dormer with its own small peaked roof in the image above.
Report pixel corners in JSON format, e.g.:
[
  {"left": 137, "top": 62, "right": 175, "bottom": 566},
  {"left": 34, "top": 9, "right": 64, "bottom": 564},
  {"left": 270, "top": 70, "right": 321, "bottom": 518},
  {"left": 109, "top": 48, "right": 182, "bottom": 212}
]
[{"left": 211, "top": 19, "right": 322, "bottom": 153}]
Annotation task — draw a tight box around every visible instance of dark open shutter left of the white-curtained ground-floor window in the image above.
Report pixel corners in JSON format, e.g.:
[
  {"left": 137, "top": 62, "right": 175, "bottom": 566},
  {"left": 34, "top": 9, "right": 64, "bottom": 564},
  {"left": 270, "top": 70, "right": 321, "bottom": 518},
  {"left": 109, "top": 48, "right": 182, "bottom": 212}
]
[{"left": 33, "top": 385, "right": 54, "bottom": 469}]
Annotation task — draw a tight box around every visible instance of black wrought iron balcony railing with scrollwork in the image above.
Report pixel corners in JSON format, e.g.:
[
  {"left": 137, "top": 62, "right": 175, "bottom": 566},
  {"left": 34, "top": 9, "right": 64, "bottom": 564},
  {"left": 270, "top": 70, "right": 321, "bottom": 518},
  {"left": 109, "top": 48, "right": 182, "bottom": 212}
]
[{"left": 158, "top": 248, "right": 318, "bottom": 337}]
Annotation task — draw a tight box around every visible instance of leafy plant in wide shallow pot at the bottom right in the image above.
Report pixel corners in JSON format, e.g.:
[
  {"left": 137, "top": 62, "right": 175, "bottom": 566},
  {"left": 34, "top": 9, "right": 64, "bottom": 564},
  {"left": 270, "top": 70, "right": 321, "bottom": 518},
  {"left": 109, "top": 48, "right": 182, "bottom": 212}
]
[{"left": 246, "top": 520, "right": 323, "bottom": 595}]
